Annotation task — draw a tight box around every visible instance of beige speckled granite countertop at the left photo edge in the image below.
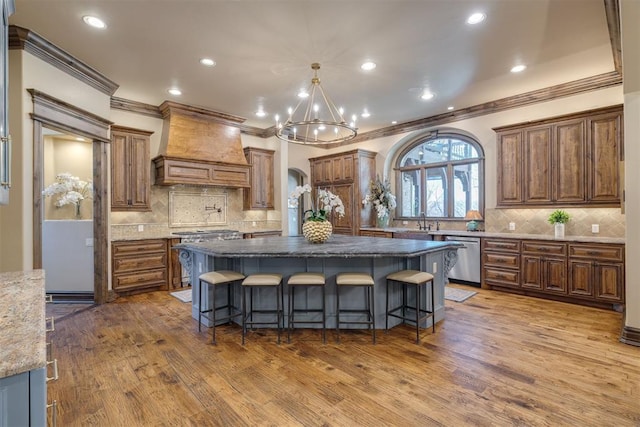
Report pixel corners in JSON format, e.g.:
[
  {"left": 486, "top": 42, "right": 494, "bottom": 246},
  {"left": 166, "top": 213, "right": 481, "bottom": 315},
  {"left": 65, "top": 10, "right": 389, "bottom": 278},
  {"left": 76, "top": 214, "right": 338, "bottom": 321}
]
[{"left": 0, "top": 270, "right": 47, "bottom": 378}]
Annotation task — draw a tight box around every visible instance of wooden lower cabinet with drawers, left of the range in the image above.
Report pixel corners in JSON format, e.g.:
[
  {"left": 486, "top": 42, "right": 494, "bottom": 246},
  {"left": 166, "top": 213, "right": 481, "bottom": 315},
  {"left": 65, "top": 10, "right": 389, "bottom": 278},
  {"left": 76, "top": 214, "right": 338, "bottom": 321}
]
[{"left": 111, "top": 239, "right": 169, "bottom": 294}]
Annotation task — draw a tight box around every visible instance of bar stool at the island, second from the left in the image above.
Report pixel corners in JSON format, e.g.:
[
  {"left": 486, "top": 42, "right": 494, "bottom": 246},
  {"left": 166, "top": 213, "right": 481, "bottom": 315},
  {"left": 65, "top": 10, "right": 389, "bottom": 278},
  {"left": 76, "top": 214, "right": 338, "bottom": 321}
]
[{"left": 242, "top": 273, "right": 284, "bottom": 345}]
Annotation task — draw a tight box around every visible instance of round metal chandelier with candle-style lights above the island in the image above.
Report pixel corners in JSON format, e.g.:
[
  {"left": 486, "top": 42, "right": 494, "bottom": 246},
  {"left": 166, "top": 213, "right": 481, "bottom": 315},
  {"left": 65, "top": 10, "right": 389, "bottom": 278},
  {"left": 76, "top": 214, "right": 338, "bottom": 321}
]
[{"left": 275, "top": 62, "right": 358, "bottom": 145}]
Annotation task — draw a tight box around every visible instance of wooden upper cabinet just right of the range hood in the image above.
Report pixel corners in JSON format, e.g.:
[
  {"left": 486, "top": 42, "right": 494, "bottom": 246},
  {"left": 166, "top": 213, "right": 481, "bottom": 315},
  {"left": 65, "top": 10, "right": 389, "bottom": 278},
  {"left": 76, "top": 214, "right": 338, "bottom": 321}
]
[{"left": 244, "top": 147, "right": 275, "bottom": 210}]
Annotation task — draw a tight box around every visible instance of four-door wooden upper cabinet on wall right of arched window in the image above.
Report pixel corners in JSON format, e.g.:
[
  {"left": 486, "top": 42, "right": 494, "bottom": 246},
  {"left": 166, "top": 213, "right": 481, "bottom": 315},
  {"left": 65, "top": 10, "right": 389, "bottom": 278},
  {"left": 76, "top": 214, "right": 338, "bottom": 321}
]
[{"left": 494, "top": 106, "right": 622, "bottom": 207}]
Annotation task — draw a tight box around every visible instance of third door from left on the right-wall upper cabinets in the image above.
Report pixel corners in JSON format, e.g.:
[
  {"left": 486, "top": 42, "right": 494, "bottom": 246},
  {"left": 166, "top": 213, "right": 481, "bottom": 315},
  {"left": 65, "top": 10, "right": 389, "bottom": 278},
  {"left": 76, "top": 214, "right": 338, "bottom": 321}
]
[{"left": 553, "top": 119, "right": 586, "bottom": 203}]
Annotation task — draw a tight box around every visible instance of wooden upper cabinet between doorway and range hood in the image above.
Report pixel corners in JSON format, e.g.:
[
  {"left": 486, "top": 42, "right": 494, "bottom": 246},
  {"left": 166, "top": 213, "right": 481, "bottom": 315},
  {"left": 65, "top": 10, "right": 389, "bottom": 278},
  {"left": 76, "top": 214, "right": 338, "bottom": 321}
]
[{"left": 111, "top": 126, "right": 153, "bottom": 211}]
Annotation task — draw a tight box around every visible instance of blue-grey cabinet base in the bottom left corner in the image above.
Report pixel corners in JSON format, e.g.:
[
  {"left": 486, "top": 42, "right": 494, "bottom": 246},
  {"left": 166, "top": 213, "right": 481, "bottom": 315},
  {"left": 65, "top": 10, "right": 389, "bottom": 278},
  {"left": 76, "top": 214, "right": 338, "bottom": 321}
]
[{"left": 0, "top": 368, "right": 47, "bottom": 427}]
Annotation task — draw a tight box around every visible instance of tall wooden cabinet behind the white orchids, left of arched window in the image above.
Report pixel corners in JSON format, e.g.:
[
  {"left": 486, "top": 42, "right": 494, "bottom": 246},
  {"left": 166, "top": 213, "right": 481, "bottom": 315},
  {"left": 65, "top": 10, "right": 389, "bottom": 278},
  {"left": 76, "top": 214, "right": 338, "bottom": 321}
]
[{"left": 309, "top": 150, "right": 376, "bottom": 236}]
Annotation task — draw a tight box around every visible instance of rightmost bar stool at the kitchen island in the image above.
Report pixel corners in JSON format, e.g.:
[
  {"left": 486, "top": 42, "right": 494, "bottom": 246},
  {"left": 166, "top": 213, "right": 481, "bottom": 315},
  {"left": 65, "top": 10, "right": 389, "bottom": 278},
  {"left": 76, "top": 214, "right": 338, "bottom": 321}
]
[{"left": 385, "top": 270, "right": 436, "bottom": 344}]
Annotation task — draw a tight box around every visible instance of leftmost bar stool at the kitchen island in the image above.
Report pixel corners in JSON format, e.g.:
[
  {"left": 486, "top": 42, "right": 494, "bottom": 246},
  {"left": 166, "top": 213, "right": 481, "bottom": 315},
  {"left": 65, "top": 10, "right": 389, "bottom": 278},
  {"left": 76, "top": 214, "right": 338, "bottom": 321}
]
[{"left": 198, "top": 270, "right": 244, "bottom": 344}]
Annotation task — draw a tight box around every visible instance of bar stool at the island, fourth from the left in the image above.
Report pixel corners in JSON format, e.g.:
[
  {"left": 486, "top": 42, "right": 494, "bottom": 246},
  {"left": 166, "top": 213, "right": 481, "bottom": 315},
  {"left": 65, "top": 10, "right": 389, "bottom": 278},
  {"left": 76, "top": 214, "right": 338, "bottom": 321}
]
[{"left": 336, "top": 273, "right": 376, "bottom": 344}]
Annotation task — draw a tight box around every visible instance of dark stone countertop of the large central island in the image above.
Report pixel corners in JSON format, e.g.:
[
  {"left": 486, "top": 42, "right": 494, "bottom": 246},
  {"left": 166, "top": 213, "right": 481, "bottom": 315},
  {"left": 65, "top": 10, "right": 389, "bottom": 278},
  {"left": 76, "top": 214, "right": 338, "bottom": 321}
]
[{"left": 174, "top": 234, "right": 461, "bottom": 258}]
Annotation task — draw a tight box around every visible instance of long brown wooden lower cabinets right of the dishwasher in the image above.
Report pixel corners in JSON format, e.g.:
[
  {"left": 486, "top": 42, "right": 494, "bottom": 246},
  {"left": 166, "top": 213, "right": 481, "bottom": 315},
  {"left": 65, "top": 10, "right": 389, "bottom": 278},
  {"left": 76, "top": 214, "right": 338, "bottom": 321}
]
[{"left": 482, "top": 238, "right": 625, "bottom": 308}]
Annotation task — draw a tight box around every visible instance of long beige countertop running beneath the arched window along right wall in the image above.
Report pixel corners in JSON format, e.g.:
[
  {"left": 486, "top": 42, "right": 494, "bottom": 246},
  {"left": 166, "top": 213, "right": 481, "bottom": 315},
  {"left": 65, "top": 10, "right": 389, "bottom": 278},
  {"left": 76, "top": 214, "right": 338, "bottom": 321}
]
[{"left": 362, "top": 227, "right": 625, "bottom": 244}]
